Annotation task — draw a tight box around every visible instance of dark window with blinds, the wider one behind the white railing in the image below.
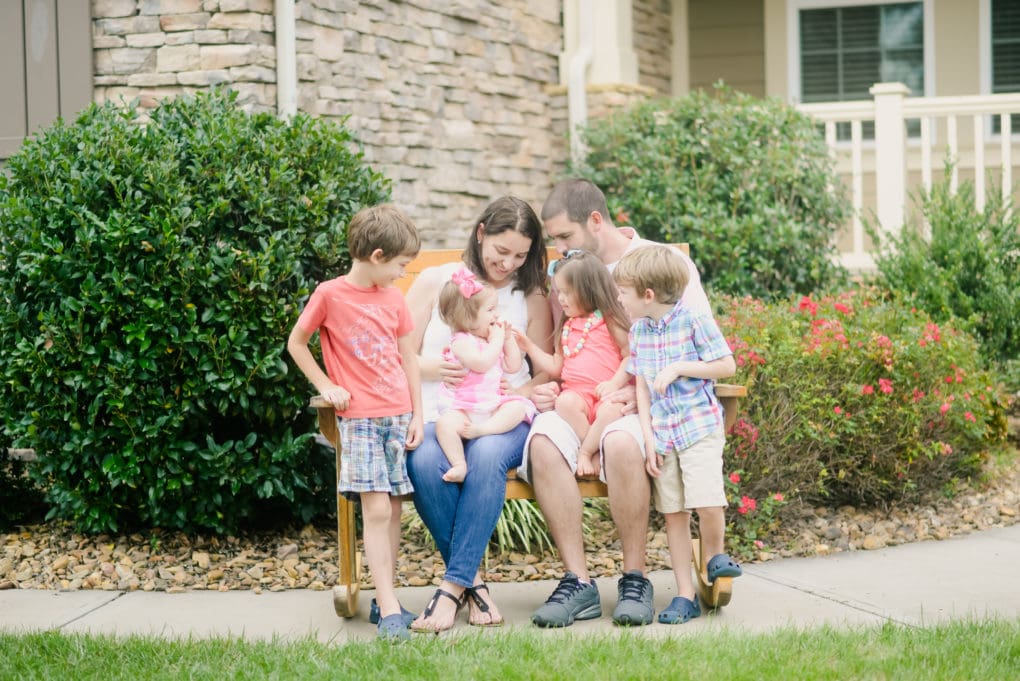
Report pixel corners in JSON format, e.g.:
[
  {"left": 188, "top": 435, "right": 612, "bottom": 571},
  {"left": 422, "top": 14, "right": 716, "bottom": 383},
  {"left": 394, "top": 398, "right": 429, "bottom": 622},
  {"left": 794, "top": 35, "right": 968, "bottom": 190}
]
[{"left": 799, "top": 2, "right": 930, "bottom": 140}]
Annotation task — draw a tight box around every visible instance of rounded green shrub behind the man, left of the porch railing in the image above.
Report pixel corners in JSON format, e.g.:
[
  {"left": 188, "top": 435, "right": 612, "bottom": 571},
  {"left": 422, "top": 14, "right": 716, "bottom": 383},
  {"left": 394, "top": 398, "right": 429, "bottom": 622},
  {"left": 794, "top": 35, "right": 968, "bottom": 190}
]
[{"left": 570, "top": 83, "right": 850, "bottom": 299}]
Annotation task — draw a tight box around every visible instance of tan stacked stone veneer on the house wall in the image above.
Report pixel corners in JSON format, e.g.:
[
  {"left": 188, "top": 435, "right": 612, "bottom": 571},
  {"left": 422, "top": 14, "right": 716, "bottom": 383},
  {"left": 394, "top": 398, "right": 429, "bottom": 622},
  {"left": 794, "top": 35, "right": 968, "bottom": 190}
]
[{"left": 92, "top": 0, "right": 668, "bottom": 248}]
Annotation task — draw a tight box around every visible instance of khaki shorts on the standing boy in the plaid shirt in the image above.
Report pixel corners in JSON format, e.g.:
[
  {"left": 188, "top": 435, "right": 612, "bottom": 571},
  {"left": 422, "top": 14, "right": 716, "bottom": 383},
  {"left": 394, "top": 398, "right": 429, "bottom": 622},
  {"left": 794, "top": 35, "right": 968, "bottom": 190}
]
[{"left": 652, "top": 426, "right": 726, "bottom": 513}]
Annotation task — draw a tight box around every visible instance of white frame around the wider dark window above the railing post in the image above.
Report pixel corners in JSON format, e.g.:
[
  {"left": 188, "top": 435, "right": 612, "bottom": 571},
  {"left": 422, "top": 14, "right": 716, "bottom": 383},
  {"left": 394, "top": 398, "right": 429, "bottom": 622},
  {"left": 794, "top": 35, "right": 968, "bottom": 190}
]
[{"left": 786, "top": 0, "right": 934, "bottom": 104}]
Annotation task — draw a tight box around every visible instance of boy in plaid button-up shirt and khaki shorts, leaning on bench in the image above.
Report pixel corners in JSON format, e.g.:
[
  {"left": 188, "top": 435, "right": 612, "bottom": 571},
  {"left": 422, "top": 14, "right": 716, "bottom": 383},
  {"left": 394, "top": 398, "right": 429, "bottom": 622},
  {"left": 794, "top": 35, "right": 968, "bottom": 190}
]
[{"left": 613, "top": 246, "right": 742, "bottom": 624}]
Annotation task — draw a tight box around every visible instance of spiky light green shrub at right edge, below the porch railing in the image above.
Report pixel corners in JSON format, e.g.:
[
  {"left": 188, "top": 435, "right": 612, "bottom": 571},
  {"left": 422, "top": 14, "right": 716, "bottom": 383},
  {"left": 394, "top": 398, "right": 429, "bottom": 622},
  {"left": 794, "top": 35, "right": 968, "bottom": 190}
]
[{"left": 869, "top": 166, "right": 1020, "bottom": 390}]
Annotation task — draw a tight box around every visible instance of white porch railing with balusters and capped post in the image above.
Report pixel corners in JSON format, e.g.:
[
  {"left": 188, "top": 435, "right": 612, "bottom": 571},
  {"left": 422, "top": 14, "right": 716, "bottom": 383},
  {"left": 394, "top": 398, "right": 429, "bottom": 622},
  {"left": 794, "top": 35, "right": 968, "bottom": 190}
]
[{"left": 798, "top": 83, "right": 1020, "bottom": 270}]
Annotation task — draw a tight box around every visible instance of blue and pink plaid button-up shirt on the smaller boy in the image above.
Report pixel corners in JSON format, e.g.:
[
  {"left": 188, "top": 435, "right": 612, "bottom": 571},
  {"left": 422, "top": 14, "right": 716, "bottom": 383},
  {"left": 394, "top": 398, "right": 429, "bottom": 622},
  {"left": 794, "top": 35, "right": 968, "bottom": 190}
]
[{"left": 627, "top": 302, "right": 732, "bottom": 454}]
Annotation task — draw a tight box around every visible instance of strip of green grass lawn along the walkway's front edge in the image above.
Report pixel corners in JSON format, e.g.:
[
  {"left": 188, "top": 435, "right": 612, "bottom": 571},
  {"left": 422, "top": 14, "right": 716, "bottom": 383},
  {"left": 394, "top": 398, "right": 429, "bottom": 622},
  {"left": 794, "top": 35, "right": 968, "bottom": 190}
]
[{"left": 0, "top": 619, "right": 1020, "bottom": 681}]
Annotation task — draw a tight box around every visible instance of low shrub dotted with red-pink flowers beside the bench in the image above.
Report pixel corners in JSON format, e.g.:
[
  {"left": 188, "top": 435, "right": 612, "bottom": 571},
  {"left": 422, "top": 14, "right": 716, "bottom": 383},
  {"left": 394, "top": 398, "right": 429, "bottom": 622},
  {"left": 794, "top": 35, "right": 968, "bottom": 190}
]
[{"left": 718, "top": 287, "right": 1006, "bottom": 506}]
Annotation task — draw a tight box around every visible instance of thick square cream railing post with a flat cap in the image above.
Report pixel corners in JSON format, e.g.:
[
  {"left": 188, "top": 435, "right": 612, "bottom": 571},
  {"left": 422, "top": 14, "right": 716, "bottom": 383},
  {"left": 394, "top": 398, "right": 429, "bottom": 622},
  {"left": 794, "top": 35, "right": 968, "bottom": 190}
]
[{"left": 868, "top": 83, "right": 910, "bottom": 239}]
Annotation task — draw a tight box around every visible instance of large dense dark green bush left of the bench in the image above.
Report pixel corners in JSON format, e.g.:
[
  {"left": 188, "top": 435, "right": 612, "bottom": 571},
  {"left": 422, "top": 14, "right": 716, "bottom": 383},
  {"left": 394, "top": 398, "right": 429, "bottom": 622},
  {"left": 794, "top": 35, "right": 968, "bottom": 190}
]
[{"left": 0, "top": 92, "right": 389, "bottom": 531}]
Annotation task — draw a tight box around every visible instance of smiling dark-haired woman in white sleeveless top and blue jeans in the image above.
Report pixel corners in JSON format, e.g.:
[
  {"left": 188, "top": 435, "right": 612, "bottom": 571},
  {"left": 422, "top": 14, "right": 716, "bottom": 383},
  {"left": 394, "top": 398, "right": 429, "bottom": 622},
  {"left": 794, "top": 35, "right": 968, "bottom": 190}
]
[{"left": 407, "top": 197, "right": 552, "bottom": 631}]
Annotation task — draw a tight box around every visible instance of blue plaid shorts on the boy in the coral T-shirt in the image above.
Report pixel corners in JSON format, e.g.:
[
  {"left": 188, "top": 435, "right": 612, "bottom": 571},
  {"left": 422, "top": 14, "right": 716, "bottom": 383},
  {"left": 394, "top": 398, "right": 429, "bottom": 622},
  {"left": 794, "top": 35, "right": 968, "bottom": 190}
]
[{"left": 337, "top": 413, "right": 414, "bottom": 496}]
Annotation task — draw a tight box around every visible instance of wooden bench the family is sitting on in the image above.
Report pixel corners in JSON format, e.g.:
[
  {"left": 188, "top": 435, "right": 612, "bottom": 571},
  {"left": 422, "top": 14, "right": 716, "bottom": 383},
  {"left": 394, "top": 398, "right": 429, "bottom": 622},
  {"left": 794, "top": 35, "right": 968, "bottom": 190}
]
[{"left": 310, "top": 244, "right": 748, "bottom": 617}]
